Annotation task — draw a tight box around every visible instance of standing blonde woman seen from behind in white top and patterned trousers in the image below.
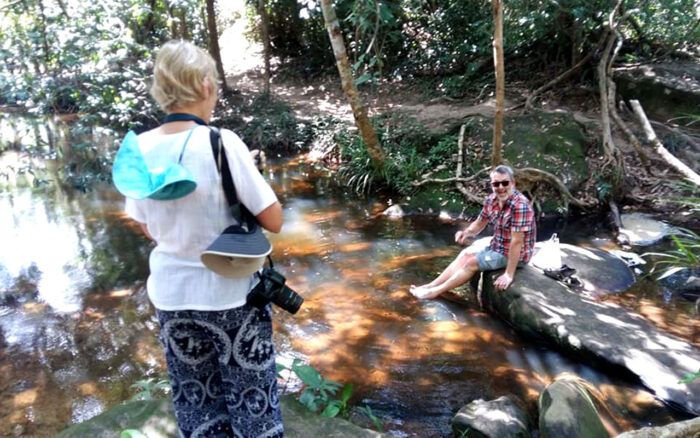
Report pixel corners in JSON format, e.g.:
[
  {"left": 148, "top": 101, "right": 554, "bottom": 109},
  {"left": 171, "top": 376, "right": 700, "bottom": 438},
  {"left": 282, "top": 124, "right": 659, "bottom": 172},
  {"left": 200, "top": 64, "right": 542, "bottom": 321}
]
[{"left": 125, "top": 41, "right": 283, "bottom": 438}]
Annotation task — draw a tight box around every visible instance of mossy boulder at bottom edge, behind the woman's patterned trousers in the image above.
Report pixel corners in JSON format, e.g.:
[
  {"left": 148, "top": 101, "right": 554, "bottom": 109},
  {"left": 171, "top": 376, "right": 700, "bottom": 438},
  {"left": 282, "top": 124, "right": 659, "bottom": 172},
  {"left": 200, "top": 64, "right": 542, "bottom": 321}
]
[{"left": 58, "top": 394, "right": 383, "bottom": 438}]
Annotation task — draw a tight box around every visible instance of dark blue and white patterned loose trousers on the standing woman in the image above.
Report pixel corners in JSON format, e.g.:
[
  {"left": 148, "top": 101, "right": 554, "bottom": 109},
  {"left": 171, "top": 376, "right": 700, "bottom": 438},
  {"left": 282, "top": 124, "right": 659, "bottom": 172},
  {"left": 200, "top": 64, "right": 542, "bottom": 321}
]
[{"left": 156, "top": 305, "right": 283, "bottom": 438}]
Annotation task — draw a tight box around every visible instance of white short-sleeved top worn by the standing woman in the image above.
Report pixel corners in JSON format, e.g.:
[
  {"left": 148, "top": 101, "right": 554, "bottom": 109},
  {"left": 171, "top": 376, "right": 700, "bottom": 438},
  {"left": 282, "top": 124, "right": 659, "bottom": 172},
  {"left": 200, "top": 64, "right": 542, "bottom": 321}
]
[{"left": 125, "top": 126, "right": 277, "bottom": 310}]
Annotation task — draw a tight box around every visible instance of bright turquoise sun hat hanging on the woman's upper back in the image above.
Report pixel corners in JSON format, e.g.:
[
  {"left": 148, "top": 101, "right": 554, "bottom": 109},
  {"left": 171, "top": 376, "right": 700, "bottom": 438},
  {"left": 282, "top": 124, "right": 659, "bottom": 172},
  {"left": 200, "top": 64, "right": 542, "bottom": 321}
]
[{"left": 112, "top": 128, "right": 197, "bottom": 201}]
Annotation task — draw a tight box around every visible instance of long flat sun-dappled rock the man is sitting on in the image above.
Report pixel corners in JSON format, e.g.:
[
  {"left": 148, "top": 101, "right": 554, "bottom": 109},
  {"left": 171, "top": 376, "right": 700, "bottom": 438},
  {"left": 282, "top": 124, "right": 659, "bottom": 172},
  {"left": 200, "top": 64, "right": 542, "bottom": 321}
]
[{"left": 482, "top": 262, "right": 700, "bottom": 415}]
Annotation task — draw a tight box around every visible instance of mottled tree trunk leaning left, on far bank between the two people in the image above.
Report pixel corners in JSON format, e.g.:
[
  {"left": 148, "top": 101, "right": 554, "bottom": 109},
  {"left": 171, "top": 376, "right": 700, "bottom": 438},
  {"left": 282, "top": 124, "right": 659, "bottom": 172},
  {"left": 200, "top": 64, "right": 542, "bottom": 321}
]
[{"left": 321, "top": 0, "right": 385, "bottom": 168}]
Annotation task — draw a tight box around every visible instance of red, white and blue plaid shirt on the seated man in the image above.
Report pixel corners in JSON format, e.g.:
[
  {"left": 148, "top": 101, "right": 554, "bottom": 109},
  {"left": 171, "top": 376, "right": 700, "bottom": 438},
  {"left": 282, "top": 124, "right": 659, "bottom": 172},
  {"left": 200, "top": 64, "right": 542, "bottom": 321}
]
[{"left": 477, "top": 189, "right": 537, "bottom": 263}]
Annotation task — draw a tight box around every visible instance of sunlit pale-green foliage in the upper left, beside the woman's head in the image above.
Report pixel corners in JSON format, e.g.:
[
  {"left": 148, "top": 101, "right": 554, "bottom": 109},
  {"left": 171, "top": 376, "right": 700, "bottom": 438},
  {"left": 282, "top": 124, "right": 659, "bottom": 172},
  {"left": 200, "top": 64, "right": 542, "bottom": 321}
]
[{"left": 0, "top": 0, "right": 207, "bottom": 129}]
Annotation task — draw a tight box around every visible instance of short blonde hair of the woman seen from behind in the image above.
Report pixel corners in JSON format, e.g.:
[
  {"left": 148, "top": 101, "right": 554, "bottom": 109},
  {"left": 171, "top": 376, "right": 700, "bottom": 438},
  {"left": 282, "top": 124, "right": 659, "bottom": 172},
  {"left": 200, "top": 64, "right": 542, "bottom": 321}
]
[{"left": 151, "top": 40, "right": 218, "bottom": 112}]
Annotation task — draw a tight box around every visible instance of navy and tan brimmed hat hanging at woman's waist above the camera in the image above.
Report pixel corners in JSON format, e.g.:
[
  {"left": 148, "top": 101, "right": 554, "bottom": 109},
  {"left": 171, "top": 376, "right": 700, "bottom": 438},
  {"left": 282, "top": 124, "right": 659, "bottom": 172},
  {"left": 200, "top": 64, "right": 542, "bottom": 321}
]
[{"left": 200, "top": 225, "right": 272, "bottom": 278}]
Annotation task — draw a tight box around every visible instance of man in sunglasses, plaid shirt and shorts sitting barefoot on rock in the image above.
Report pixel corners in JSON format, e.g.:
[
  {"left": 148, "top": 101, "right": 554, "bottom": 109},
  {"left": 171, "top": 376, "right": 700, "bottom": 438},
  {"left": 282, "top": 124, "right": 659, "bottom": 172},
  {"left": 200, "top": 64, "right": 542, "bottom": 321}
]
[{"left": 411, "top": 165, "right": 536, "bottom": 299}]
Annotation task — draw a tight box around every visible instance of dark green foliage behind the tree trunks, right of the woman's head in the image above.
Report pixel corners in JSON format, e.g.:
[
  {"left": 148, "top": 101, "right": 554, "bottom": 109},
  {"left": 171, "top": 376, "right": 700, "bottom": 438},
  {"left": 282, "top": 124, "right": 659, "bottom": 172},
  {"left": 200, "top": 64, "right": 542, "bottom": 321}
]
[{"left": 258, "top": 0, "right": 700, "bottom": 90}]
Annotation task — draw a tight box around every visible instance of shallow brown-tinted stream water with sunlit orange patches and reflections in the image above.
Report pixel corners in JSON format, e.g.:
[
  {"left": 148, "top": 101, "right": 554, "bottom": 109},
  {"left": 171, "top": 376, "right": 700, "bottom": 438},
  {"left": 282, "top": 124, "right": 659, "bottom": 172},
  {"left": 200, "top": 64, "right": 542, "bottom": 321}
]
[{"left": 0, "top": 157, "right": 700, "bottom": 437}]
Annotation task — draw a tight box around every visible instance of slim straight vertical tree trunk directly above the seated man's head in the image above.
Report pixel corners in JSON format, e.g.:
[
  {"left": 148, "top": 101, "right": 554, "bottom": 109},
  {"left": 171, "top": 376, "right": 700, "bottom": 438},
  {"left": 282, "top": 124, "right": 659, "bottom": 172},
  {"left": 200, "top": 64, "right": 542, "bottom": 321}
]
[{"left": 491, "top": 0, "right": 505, "bottom": 167}]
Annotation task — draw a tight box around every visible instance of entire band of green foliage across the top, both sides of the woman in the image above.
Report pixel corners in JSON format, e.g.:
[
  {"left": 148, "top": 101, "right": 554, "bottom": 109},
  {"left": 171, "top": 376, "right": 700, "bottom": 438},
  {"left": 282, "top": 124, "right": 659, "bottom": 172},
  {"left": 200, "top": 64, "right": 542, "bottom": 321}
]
[{"left": 0, "top": 0, "right": 700, "bottom": 120}]
